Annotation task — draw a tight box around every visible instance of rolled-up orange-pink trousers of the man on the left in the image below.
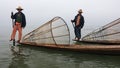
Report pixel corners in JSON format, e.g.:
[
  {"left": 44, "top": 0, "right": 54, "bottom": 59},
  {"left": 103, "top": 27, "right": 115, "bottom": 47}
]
[{"left": 11, "top": 22, "right": 22, "bottom": 40}]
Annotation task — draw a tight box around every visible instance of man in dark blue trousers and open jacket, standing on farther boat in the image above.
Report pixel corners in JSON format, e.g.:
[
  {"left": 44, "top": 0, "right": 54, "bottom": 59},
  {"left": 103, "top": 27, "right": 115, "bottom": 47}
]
[{"left": 71, "top": 9, "right": 84, "bottom": 41}]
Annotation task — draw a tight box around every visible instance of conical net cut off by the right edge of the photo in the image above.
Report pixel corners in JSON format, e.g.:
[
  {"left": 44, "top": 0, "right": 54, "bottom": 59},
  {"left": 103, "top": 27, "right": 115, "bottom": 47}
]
[{"left": 82, "top": 18, "right": 120, "bottom": 43}]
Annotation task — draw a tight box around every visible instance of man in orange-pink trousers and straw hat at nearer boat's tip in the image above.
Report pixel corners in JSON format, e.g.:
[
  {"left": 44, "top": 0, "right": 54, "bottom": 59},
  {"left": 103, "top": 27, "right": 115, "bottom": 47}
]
[{"left": 10, "top": 6, "right": 26, "bottom": 43}]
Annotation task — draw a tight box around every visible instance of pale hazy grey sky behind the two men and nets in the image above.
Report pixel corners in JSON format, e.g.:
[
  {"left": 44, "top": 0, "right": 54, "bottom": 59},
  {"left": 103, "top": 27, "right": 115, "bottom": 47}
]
[{"left": 0, "top": 0, "right": 120, "bottom": 38}]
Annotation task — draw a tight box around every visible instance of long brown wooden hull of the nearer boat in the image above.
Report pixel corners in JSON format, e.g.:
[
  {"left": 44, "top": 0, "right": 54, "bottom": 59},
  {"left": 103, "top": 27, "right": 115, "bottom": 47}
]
[{"left": 21, "top": 42, "right": 120, "bottom": 55}]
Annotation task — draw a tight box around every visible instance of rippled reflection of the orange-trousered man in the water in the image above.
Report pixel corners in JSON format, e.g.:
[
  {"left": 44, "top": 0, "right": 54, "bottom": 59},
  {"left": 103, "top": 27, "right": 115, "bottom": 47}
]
[{"left": 9, "top": 46, "right": 29, "bottom": 68}]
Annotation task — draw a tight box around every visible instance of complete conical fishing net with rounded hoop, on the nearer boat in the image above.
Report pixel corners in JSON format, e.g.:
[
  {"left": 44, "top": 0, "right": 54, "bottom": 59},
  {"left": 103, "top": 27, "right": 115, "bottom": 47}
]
[{"left": 22, "top": 17, "right": 70, "bottom": 45}]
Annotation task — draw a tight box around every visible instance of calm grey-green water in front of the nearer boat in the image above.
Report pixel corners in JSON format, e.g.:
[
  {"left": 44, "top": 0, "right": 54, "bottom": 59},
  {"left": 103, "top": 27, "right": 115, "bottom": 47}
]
[{"left": 0, "top": 40, "right": 120, "bottom": 68}]
